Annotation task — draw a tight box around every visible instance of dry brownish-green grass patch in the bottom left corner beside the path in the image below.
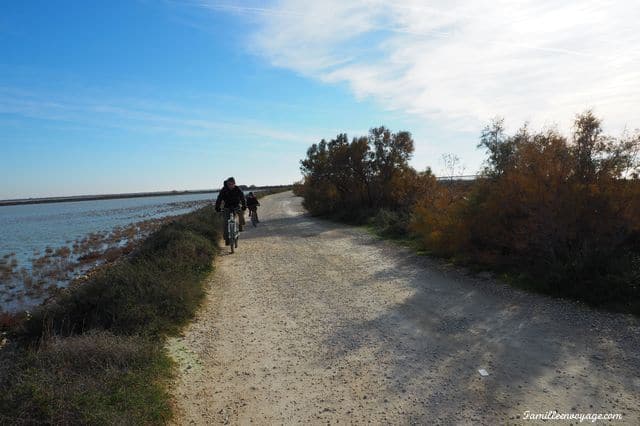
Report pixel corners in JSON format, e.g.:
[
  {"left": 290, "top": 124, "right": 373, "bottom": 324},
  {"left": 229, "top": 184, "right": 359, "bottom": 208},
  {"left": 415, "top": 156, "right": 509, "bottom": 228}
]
[{"left": 0, "top": 332, "right": 171, "bottom": 425}]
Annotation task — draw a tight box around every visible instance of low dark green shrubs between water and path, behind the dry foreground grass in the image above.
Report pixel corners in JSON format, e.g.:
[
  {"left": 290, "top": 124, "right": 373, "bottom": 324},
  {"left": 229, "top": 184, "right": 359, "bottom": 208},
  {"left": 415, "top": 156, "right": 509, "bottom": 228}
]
[{"left": 22, "top": 207, "right": 221, "bottom": 338}]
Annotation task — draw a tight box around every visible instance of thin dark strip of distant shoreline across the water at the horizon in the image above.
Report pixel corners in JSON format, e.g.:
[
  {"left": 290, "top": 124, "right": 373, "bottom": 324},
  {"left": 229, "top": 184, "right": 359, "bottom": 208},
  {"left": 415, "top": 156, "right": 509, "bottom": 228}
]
[{"left": 0, "top": 185, "right": 290, "bottom": 207}]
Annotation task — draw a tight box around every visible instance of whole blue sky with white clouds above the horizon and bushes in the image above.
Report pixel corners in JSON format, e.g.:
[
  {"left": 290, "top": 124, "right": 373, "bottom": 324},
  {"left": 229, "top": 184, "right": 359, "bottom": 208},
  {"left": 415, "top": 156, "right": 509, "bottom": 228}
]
[{"left": 0, "top": 0, "right": 640, "bottom": 199}]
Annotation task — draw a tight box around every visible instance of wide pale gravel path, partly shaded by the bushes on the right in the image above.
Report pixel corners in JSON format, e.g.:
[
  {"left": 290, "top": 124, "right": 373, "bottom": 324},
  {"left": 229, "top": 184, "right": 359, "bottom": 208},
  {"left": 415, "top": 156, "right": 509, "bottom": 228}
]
[{"left": 169, "top": 193, "right": 640, "bottom": 425}]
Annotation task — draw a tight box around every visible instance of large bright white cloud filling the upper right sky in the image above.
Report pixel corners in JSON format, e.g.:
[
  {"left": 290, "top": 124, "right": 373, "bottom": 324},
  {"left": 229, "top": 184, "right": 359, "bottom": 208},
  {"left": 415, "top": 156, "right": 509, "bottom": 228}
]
[{"left": 208, "top": 0, "right": 640, "bottom": 131}]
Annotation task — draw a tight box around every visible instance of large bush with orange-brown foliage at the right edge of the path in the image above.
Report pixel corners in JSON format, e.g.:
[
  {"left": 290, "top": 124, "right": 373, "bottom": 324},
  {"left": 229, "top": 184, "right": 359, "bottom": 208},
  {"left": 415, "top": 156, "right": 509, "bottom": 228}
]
[{"left": 412, "top": 111, "right": 640, "bottom": 312}]
